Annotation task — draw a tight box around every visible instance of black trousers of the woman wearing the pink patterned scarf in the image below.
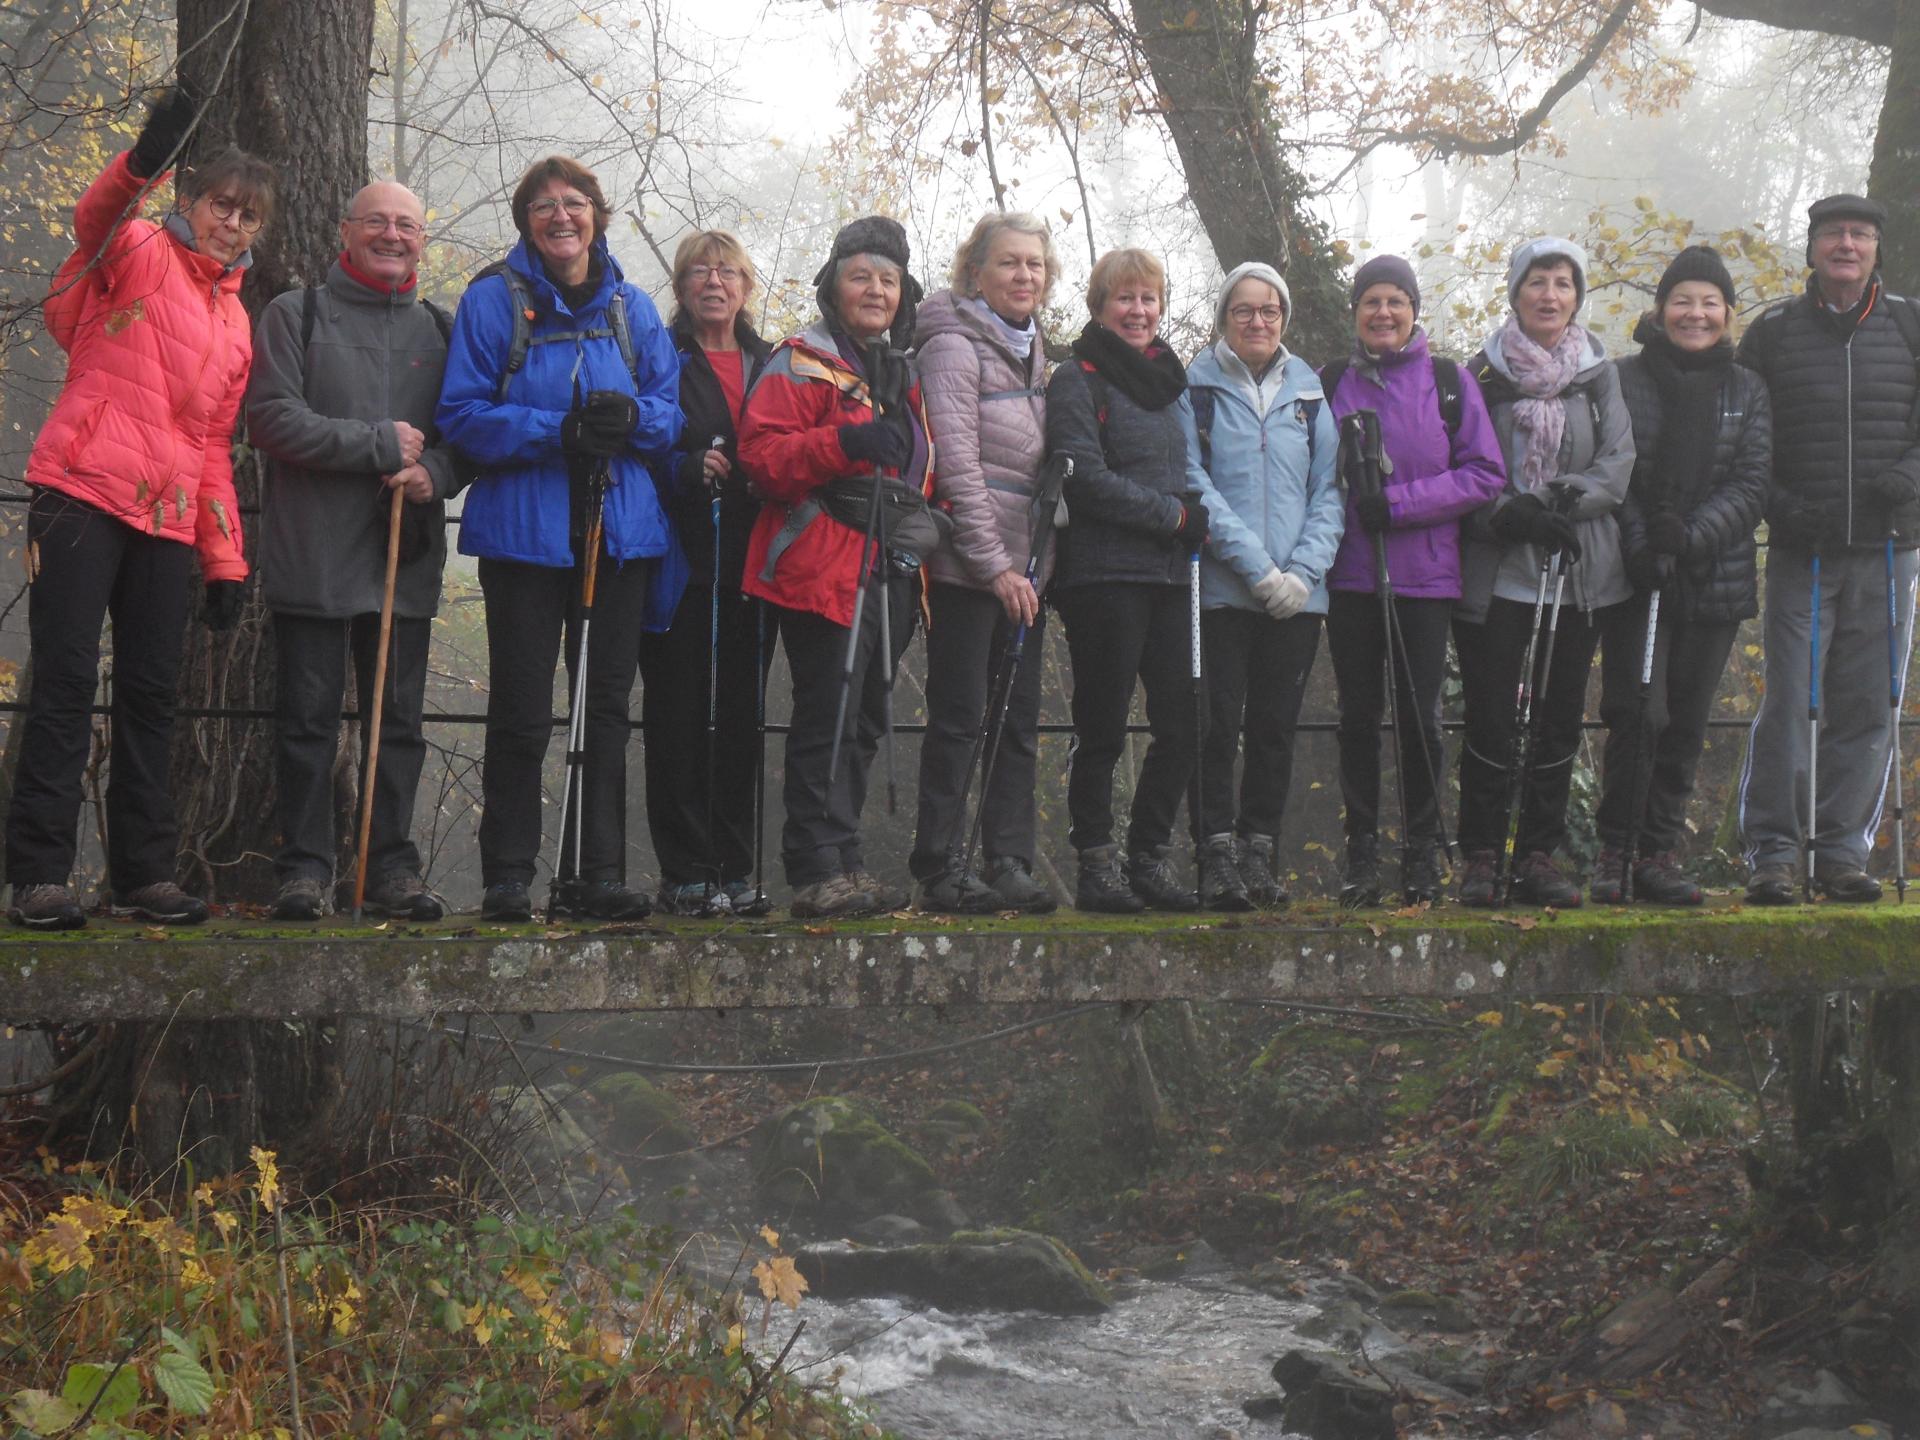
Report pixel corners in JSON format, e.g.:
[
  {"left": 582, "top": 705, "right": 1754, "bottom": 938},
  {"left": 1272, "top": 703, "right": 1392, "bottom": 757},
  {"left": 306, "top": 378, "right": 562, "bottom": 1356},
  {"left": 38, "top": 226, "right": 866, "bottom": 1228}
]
[{"left": 1453, "top": 597, "right": 1605, "bottom": 854}]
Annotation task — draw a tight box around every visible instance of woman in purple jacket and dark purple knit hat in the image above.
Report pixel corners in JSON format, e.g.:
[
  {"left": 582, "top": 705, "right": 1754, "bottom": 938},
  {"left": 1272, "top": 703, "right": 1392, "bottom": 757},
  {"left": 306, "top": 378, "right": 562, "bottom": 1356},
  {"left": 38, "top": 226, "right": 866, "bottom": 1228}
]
[{"left": 1321, "top": 255, "right": 1505, "bottom": 906}]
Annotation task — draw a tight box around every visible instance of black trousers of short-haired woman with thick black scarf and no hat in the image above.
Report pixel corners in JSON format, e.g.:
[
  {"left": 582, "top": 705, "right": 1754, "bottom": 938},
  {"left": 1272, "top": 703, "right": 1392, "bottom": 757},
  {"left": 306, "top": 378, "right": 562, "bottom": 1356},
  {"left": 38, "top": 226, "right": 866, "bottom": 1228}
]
[{"left": 1054, "top": 582, "right": 1200, "bottom": 852}]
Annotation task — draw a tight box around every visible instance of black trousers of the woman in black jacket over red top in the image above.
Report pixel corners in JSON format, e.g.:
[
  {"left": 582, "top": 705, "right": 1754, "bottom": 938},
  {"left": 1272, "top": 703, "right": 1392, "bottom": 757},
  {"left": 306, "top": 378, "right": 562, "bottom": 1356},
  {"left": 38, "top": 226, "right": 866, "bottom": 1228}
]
[{"left": 639, "top": 586, "right": 776, "bottom": 885}]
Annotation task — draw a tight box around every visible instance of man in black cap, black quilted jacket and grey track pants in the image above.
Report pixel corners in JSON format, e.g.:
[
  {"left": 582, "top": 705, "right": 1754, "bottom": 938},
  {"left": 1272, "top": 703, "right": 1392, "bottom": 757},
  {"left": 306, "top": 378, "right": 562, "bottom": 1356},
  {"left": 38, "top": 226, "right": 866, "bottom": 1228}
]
[{"left": 1740, "top": 196, "right": 1920, "bottom": 904}]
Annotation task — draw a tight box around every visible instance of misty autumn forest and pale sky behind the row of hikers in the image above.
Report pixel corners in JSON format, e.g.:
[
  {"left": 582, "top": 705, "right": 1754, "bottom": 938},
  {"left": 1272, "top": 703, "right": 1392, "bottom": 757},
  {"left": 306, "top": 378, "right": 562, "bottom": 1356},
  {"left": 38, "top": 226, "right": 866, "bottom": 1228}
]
[{"left": 0, "top": 0, "right": 1896, "bottom": 904}]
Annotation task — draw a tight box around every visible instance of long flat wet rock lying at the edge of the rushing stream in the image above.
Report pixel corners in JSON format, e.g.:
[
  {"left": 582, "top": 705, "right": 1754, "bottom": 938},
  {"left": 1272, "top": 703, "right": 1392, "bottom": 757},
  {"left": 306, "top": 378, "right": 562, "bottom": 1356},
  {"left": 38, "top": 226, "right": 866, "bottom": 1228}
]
[{"left": 793, "top": 1231, "right": 1112, "bottom": 1315}]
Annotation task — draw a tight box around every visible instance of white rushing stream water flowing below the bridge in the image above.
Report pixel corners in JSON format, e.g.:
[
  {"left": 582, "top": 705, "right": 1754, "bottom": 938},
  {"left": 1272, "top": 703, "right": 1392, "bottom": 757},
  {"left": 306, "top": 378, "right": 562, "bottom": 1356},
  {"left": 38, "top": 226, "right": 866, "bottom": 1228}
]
[{"left": 762, "top": 1275, "right": 1315, "bottom": 1440}]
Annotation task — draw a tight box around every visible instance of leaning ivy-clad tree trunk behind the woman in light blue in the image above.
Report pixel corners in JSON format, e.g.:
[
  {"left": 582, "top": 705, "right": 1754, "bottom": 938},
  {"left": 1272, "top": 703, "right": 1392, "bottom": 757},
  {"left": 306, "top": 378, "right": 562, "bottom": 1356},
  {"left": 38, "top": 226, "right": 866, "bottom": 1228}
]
[{"left": 1133, "top": 0, "right": 1350, "bottom": 357}]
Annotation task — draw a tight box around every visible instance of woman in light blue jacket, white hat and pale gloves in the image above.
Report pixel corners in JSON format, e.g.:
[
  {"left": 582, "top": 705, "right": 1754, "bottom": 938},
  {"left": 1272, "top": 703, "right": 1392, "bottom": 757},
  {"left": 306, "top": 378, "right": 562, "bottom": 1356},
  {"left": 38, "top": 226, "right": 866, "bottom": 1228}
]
[{"left": 1187, "top": 261, "right": 1346, "bottom": 910}]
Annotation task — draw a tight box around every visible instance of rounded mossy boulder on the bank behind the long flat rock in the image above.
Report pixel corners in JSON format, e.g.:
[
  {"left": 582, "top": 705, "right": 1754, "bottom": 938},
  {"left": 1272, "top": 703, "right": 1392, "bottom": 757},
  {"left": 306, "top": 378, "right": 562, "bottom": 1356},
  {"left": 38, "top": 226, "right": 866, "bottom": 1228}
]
[{"left": 749, "top": 1094, "right": 937, "bottom": 1221}]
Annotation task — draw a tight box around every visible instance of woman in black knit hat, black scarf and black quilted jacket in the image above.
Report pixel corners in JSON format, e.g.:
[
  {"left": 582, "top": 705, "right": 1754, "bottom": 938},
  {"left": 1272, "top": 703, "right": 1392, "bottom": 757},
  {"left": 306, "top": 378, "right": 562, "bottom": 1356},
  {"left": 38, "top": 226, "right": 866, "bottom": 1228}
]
[{"left": 1592, "top": 246, "right": 1772, "bottom": 904}]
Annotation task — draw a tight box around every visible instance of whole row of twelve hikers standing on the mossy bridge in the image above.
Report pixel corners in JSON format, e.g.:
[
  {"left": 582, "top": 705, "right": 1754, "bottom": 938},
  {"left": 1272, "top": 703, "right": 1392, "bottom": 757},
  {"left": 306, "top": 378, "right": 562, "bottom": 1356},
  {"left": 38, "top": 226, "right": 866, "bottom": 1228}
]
[{"left": 6, "top": 94, "right": 1920, "bottom": 929}]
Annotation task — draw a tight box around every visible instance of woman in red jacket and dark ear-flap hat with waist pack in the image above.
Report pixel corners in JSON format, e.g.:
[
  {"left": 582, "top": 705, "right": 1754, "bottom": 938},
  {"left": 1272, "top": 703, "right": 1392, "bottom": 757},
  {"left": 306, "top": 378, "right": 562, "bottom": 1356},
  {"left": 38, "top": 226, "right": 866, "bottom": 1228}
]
[{"left": 739, "top": 215, "right": 937, "bottom": 916}]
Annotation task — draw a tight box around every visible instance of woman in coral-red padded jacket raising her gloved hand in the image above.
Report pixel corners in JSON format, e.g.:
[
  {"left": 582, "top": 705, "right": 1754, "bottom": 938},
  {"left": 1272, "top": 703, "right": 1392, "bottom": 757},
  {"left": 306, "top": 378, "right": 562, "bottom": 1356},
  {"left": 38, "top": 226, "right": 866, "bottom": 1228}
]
[{"left": 6, "top": 92, "right": 273, "bottom": 929}]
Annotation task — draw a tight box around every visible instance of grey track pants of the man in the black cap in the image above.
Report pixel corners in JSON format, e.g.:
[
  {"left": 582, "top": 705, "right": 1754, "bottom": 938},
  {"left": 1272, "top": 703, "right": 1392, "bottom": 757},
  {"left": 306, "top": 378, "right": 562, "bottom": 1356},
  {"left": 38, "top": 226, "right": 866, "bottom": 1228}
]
[{"left": 1740, "top": 545, "right": 1920, "bottom": 874}]
